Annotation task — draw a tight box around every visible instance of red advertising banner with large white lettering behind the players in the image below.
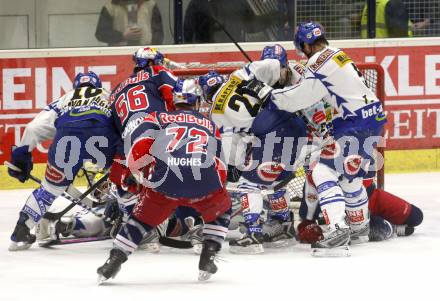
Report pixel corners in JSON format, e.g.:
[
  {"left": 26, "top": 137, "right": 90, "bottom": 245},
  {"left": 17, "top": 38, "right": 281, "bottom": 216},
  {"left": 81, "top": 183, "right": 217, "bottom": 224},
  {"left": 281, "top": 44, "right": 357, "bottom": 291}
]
[{"left": 0, "top": 46, "right": 440, "bottom": 162}]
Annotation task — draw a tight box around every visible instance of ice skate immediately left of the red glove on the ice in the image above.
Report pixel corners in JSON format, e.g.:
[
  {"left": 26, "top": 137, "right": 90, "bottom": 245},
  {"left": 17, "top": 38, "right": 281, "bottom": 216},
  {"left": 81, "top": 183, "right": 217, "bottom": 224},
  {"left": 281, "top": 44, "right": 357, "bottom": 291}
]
[{"left": 263, "top": 214, "right": 295, "bottom": 248}]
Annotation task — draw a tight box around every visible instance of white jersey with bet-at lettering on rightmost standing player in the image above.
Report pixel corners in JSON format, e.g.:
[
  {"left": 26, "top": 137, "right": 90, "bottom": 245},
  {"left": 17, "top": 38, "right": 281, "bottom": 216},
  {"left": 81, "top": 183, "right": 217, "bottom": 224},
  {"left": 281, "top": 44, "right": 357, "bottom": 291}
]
[{"left": 272, "top": 47, "right": 386, "bottom": 131}]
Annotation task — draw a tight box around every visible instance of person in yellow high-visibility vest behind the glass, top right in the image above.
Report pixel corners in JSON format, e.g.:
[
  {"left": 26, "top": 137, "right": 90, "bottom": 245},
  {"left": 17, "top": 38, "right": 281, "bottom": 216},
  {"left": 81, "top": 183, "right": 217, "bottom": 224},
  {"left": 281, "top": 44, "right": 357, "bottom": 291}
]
[{"left": 361, "top": 0, "right": 413, "bottom": 38}]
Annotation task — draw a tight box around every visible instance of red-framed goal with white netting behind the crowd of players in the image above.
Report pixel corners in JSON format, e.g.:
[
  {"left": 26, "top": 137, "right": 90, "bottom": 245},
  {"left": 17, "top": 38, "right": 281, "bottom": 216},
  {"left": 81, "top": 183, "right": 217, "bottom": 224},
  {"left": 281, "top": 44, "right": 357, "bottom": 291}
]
[{"left": 173, "top": 63, "right": 385, "bottom": 200}]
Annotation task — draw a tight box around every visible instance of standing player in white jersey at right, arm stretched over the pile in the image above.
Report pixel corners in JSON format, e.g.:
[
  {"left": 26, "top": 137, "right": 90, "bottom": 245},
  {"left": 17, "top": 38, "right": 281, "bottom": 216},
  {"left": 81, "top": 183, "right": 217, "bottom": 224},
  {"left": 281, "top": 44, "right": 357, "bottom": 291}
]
[{"left": 242, "top": 22, "right": 386, "bottom": 256}]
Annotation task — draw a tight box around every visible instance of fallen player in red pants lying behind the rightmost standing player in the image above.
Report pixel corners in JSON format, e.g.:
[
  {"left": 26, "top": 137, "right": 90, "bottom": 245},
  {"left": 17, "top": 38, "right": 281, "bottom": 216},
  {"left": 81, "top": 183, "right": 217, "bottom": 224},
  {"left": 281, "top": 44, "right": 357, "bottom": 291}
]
[{"left": 297, "top": 177, "right": 423, "bottom": 243}]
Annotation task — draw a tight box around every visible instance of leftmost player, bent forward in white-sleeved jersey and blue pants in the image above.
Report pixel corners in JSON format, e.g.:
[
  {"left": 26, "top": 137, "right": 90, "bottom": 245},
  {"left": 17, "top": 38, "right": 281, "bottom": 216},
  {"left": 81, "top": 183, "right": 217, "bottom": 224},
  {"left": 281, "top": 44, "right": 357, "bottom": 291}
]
[{"left": 8, "top": 71, "right": 119, "bottom": 251}]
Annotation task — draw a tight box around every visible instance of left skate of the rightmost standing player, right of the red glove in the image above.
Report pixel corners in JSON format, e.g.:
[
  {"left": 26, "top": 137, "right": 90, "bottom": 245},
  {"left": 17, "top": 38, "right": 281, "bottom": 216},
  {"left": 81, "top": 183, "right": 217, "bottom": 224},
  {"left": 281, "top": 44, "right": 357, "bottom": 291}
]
[{"left": 311, "top": 224, "right": 350, "bottom": 257}]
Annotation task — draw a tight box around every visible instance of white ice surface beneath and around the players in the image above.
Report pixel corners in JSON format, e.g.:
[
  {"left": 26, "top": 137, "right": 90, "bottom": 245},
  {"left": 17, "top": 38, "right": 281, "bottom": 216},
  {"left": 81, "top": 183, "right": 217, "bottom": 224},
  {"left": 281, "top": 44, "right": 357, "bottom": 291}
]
[{"left": 0, "top": 173, "right": 440, "bottom": 301}]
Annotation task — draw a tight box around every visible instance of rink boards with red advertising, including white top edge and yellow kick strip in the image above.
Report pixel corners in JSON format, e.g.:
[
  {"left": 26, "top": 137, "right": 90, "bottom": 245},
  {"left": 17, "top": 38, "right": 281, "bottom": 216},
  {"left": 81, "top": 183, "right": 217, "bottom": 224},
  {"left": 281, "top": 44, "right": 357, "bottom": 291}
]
[{"left": 0, "top": 38, "right": 440, "bottom": 188}]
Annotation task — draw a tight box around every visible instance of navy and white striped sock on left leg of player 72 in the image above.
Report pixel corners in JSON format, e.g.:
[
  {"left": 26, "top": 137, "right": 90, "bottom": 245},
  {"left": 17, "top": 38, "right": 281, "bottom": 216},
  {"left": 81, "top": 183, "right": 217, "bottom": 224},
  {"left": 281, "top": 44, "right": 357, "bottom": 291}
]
[{"left": 113, "top": 216, "right": 156, "bottom": 255}]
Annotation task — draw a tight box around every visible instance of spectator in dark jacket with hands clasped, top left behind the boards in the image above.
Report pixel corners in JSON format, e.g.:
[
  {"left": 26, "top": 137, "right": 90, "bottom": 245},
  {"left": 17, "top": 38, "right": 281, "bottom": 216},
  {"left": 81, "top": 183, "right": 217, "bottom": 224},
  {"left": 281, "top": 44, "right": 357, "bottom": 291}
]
[{"left": 95, "top": 0, "right": 163, "bottom": 46}]
